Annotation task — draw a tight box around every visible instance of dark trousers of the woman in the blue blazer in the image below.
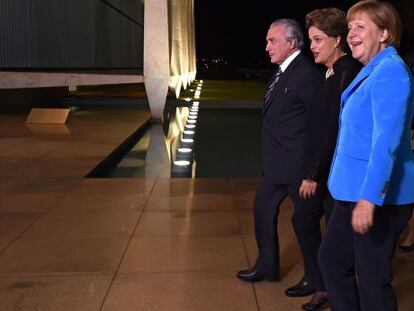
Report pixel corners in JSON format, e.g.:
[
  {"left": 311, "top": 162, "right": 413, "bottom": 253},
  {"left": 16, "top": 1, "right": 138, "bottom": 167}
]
[{"left": 319, "top": 202, "right": 412, "bottom": 311}]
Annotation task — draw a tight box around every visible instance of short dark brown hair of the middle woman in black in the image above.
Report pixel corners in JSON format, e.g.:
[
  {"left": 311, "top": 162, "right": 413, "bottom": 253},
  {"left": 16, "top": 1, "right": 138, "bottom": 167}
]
[{"left": 305, "top": 8, "right": 348, "bottom": 51}]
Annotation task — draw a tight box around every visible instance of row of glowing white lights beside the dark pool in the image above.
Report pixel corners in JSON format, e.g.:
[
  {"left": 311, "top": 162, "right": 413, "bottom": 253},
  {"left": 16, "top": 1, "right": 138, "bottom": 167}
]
[{"left": 171, "top": 80, "right": 203, "bottom": 177}]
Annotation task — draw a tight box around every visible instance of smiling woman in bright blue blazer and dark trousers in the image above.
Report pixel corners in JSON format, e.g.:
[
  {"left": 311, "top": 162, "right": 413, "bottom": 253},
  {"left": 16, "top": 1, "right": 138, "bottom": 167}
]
[{"left": 319, "top": 0, "right": 414, "bottom": 311}]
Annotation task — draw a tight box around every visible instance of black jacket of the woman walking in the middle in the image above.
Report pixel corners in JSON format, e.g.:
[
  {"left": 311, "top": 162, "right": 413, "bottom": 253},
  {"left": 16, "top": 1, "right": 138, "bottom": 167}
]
[{"left": 304, "top": 55, "right": 362, "bottom": 183}]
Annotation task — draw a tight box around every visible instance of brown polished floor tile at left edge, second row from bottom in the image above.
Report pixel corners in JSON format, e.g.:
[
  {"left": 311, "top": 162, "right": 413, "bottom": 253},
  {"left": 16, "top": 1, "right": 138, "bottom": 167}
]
[{"left": 0, "top": 237, "right": 128, "bottom": 275}]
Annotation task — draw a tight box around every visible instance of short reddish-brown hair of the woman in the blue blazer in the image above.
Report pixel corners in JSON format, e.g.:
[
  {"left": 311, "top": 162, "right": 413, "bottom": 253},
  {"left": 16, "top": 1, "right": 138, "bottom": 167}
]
[{"left": 346, "top": 0, "right": 402, "bottom": 47}]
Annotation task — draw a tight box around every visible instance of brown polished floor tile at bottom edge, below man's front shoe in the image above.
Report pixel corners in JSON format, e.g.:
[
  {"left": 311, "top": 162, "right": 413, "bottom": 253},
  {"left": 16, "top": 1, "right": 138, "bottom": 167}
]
[{"left": 103, "top": 273, "right": 257, "bottom": 311}]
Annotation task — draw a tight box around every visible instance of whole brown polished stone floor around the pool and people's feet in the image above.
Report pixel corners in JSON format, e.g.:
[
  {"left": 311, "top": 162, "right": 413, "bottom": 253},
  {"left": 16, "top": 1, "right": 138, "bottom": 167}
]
[{"left": 0, "top": 109, "right": 414, "bottom": 311}]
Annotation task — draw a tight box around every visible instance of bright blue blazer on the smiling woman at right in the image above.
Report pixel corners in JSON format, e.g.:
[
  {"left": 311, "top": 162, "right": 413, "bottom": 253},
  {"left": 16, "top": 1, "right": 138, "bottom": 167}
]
[{"left": 328, "top": 46, "right": 414, "bottom": 205}]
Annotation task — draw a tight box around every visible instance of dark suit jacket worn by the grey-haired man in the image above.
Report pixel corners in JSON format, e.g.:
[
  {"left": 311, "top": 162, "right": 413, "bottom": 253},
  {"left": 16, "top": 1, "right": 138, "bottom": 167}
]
[{"left": 262, "top": 53, "right": 323, "bottom": 184}]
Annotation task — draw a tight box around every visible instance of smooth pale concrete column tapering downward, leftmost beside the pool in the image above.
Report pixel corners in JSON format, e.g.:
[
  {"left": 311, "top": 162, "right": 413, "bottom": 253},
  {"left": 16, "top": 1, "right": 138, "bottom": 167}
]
[{"left": 144, "top": 0, "right": 170, "bottom": 119}]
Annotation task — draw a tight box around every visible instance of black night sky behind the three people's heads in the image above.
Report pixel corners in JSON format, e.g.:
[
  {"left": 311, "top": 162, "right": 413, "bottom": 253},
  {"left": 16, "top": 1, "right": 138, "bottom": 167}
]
[{"left": 194, "top": 0, "right": 414, "bottom": 68}]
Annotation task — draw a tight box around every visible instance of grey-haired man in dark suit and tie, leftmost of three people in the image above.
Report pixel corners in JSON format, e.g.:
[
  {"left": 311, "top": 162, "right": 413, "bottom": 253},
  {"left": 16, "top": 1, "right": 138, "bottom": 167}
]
[{"left": 237, "top": 19, "right": 323, "bottom": 297}]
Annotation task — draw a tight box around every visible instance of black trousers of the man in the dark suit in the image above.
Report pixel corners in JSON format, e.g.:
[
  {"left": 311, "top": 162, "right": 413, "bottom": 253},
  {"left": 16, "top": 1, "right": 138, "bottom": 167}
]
[{"left": 254, "top": 181, "right": 324, "bottom": 289}]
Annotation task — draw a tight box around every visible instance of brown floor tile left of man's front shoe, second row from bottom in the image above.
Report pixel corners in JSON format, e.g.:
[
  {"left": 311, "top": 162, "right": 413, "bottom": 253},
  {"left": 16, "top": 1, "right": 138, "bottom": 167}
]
[{"left": 120, "top": 237, "right": 247, "bottom": 273}]
